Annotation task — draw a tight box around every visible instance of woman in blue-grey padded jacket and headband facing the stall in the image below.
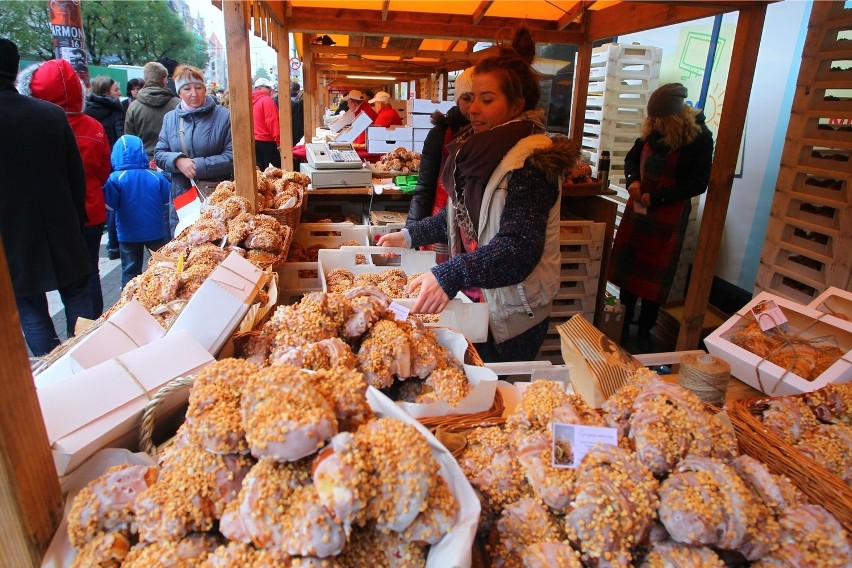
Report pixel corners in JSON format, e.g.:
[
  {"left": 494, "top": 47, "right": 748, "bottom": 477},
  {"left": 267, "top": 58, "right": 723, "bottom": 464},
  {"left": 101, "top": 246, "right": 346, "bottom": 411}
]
[{"left": 154, "top": 65, "right": 234, "bottom": 234}]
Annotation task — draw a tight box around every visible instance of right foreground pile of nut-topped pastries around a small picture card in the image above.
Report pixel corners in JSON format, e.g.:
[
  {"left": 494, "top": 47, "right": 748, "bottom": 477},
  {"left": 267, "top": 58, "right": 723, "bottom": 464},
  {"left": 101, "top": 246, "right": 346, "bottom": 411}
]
[{"left": 459, "top": 369, "right": 852, "bottom": 568}]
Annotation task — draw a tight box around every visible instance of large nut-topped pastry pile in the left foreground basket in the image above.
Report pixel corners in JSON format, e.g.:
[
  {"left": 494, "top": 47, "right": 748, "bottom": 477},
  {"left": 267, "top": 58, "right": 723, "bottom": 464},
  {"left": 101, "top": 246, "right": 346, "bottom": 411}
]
[{"left": 68, "top": 359, "right": 459, "bottom": 568}]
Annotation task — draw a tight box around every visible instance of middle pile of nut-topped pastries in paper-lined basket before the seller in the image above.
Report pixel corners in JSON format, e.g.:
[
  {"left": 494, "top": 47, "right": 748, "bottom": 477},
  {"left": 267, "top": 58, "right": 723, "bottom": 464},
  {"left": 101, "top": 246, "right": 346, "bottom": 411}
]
[{"left": 240, "top": 286, "right": 473, "bottom": 407}]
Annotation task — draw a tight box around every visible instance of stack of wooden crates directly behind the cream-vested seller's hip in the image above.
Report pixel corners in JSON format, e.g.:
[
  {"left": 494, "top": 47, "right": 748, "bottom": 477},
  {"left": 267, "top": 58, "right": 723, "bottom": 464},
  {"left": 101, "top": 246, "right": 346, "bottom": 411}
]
[{"left": 538, "top": 221, "right": 606, "bottom": 364}]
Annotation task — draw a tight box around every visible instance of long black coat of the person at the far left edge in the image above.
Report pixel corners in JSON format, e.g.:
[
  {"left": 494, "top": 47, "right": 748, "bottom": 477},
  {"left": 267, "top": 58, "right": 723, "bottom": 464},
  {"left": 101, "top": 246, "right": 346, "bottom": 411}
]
[{"left": 0, "top": 82, "right": 91, "bottom": 296}]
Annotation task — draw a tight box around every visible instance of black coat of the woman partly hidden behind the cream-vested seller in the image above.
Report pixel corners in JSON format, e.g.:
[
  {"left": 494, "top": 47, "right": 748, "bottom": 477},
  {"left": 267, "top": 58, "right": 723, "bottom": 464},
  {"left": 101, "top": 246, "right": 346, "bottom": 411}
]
[{"left": 408, "top": 107, "right": 470, "bottom": 221}]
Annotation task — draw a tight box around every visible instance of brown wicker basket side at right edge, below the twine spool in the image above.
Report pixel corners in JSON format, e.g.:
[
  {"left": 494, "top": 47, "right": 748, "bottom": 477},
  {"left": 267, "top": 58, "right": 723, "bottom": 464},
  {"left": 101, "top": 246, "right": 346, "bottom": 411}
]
[{"left": 728, "top": 395, "right": 852, "bottom": 532}]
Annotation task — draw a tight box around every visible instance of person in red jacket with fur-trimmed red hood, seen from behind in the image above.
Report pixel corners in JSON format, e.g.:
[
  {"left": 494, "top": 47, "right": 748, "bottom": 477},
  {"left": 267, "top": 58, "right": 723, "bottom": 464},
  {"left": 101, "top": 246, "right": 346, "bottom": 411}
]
[{"left": 17, "top": 59, "right": 112, "bottom": 318}]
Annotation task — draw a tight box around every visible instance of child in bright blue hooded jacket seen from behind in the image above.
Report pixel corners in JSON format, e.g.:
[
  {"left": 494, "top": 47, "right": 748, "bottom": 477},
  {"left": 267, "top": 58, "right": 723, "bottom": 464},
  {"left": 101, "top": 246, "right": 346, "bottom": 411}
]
[{"left": 104, "top": 134, "right": 169, "bottom": 288}]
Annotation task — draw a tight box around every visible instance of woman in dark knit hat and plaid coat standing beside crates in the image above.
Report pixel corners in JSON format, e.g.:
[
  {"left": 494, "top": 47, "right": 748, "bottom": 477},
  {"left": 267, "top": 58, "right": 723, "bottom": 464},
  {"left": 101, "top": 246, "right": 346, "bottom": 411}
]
[{"left": 609, "top": 83, "right": 713, "bottom": 351}]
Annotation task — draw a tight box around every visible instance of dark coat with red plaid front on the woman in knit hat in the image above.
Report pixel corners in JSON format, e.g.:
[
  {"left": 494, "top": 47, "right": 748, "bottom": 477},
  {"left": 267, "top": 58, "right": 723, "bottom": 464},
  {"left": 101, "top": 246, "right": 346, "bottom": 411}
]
[{"left": 609, "top": 124, "right": 713, "bottom": 304}]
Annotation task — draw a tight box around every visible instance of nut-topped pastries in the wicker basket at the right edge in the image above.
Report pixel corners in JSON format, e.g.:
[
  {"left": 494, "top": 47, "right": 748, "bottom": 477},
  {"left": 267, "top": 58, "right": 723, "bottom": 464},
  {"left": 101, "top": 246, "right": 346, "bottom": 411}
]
[{"left": 760, "top": 383, "right": 852, "bottom": 485}]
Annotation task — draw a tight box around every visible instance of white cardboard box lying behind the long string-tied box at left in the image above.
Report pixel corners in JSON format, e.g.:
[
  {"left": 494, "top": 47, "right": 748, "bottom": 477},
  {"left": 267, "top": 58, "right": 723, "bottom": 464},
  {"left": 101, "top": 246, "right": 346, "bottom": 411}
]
[{"left": 35, "top": 300, "right": 166, "bottom": 388}]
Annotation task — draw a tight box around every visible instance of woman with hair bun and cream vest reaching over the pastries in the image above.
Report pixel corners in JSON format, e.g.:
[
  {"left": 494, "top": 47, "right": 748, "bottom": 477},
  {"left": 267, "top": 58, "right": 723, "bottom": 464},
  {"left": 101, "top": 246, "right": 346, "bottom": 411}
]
[{"left": 379, "top": 28, "right": 579, "bottom": 362}]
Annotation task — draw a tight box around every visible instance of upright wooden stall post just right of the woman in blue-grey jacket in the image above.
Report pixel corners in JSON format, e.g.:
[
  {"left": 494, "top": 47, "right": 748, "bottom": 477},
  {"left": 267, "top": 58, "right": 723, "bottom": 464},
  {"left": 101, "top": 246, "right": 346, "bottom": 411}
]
[{"left": 222, "top": 0, "right": 257, "bottom": 211}]
